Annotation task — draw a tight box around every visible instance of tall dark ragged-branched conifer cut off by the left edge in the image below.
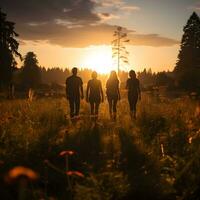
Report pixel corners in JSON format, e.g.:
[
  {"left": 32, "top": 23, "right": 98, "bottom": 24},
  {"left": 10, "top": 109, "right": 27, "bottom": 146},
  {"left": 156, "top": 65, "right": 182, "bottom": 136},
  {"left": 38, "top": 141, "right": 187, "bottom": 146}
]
[{"left": 0, "top": 9, "right": 21, "bottom": 87}]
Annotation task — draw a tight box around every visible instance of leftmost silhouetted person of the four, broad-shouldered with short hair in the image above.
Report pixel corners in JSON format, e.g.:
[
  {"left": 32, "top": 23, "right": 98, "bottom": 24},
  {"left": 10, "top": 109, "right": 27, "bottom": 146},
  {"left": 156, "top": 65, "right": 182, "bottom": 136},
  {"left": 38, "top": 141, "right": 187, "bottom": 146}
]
[{"left": 66, "top": 67, "right": 84, "bottom": 118}]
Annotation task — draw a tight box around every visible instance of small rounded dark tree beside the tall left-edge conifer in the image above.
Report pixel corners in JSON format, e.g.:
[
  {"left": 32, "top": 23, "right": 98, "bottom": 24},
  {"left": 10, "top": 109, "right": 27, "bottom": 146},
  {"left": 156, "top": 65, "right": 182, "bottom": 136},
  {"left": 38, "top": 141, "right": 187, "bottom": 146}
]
[{"left": 21, "top": 52, "right": 41, "bottom": 89}]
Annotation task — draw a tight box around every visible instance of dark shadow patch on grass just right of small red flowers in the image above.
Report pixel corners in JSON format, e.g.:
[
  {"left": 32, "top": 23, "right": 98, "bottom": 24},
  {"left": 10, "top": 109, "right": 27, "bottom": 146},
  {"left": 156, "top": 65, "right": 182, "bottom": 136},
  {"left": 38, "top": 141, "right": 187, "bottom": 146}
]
[{"left": 64, "top": 124, "right": 103, "bottom": 172}]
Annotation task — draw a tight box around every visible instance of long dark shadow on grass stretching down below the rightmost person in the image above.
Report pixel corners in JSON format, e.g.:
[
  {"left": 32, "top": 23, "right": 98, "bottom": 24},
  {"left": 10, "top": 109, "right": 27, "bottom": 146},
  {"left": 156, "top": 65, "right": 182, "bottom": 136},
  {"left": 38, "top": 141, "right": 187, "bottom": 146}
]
[{"left": 119, "top": 129, "right": 173, "bottom": 200}]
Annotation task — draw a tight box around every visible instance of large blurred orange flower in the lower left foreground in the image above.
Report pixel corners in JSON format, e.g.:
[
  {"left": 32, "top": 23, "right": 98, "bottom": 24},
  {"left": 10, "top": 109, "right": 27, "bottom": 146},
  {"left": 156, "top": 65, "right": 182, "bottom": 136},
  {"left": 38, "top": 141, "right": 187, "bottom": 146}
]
[{"left": 7, "top": 166, "right": 39, "bottom": 182}]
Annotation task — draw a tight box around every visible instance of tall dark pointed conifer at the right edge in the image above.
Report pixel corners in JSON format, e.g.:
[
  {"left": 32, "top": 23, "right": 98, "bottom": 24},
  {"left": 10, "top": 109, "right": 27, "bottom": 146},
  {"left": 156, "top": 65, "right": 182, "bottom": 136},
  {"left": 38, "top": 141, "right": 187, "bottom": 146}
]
[{"left": 174, "top": 12, "right": 200, "bottom": 90}]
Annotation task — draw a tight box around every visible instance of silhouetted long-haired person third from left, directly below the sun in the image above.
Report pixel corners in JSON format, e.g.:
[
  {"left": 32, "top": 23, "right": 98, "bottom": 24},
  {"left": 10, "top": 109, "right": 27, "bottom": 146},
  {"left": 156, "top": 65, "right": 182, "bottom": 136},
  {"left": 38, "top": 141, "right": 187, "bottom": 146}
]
[{"left": 106, "top": 71, "right": 121, "bottom": 120}]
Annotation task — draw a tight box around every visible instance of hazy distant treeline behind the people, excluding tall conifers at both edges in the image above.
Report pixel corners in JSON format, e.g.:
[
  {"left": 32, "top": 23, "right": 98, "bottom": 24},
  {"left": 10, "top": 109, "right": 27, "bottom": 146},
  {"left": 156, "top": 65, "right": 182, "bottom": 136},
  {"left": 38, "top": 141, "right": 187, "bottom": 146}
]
[{"left": 13, "top": 52, "right": 174, "bottom": 88}]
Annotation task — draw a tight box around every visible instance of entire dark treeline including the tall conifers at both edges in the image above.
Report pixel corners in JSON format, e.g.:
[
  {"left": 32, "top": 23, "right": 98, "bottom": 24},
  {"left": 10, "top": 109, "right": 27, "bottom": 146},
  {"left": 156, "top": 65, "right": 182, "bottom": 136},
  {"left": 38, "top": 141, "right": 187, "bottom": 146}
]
[{"left": 0, "top": 10, "right": 200, "bottom": 97}]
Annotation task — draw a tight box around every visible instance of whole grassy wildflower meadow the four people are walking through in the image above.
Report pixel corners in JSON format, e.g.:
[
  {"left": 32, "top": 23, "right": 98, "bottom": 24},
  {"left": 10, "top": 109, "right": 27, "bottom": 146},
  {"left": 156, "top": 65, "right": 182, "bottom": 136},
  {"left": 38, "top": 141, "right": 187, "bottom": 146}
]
[{"left": 0, "top": 93, "right": 200, "bottom": 200}]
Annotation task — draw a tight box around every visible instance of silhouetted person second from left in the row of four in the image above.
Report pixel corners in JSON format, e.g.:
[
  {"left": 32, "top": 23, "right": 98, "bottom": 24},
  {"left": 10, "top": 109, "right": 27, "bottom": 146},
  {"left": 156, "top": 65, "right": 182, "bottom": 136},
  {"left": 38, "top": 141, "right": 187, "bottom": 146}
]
[{"left": 86, "top": 71, "right": 104, "bottom": 119}]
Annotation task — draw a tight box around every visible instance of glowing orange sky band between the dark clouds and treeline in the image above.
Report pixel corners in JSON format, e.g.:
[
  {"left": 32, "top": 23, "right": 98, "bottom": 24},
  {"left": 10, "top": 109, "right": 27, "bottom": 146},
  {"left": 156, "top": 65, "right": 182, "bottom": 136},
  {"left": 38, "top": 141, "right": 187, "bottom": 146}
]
[{"left": 20, "top": 42, "right": 179, "bottom": 73}]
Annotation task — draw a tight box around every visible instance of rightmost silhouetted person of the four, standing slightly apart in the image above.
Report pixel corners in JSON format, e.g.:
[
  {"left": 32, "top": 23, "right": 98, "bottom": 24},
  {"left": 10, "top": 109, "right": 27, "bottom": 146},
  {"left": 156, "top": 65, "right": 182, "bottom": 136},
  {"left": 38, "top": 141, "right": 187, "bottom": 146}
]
[{"left": 126, "top": 70, "right": 141, "bottom": 119}]
